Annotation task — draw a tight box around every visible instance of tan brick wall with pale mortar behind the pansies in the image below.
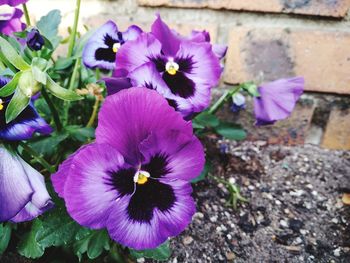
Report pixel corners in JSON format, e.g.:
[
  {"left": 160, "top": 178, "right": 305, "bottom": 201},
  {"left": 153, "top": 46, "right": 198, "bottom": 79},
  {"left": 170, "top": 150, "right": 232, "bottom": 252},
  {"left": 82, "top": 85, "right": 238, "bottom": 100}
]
[{"left": 29, "top": 0, "right": 350, "bottom": 149}]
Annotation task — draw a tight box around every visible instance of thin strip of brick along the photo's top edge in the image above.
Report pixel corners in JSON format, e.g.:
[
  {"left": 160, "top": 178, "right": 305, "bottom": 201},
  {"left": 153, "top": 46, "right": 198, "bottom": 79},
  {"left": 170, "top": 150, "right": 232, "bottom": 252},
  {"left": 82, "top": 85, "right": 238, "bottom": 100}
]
[{"left": 139, "top": 0, "right": 350, "bottom": 17}]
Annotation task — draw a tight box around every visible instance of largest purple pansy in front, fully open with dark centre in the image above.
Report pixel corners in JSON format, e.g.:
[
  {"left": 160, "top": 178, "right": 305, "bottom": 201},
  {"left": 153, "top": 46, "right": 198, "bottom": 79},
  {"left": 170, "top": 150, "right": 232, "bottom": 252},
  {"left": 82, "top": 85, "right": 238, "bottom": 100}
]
[{"left": 52, "top": 88, "right": 204, "bottom": 249}]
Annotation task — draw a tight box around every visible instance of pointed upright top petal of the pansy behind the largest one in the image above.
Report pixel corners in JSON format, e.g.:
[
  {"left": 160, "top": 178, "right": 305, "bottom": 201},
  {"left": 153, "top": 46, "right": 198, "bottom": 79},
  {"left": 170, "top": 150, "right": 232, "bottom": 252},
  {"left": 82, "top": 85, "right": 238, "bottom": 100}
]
[{"left": 151, "top": 14, "right": 181, "bottom": 56}]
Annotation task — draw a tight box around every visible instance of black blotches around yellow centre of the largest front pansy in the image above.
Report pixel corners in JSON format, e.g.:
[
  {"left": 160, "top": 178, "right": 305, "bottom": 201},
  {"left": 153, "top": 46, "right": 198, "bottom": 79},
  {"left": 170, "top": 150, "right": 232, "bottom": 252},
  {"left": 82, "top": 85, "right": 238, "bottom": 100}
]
[{"left": 106, "top": 154, "right": 176, "bottom": 223}]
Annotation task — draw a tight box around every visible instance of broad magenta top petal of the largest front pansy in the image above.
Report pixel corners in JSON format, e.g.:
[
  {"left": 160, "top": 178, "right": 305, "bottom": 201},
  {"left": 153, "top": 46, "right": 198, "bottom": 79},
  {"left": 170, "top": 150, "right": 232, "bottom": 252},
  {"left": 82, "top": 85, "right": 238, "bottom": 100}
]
[{"left": 96, "top": 88, "right": 192, "bottom": 164}]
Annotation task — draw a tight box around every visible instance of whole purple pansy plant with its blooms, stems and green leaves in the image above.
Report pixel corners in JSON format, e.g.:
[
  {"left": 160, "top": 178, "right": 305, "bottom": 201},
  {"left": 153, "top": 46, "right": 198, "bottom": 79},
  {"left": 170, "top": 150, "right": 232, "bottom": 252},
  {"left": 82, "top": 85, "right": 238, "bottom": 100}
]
[{"left": 0, "top": 0, "right": 304, "bottom": 262}]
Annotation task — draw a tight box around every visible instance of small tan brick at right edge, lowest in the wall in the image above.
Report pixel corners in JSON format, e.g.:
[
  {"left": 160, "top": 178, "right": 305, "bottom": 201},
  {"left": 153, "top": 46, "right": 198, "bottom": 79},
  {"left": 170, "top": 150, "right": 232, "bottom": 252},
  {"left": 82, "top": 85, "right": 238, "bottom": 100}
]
[{"left": 322, "top": 109, "right": 350, "bottom": 150}]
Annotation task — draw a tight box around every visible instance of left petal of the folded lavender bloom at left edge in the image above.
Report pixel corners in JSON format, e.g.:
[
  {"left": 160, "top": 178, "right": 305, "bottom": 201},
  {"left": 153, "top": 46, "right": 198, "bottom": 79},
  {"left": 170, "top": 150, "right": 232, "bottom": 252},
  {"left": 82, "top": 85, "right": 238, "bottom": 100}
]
[{"left": 0, "top": 147, "right": 34, "bottom": 222}]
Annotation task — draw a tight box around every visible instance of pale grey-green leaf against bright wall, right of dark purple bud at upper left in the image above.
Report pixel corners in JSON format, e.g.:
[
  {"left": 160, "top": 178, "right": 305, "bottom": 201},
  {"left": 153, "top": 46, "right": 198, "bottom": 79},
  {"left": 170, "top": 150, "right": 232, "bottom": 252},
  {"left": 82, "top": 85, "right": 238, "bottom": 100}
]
[{"left": 36, "top": 10, "right": 61, "bottom": 47}]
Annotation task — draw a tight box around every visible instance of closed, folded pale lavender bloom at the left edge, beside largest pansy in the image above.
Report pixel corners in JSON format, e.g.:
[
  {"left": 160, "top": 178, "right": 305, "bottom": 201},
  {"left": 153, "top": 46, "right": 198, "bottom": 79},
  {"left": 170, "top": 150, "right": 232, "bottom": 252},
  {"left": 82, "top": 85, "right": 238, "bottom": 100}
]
[{"left": 0, "top": 145, "right": 53, "bottom": 223}]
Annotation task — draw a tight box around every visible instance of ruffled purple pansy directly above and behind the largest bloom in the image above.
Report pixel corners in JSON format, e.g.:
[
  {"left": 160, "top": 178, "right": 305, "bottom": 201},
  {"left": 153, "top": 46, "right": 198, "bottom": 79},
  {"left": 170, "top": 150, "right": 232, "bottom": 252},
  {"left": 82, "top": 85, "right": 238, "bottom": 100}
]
[{"left": 116, "top": 17, "right": 221, "bottom": 117}]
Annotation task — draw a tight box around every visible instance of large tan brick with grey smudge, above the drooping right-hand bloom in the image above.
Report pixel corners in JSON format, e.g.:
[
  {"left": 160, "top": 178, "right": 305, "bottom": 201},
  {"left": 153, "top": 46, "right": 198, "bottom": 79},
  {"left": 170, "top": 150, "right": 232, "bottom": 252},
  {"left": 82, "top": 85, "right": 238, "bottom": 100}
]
[{"left": 224, "top": 27, "right": 350, "bottom": 94}]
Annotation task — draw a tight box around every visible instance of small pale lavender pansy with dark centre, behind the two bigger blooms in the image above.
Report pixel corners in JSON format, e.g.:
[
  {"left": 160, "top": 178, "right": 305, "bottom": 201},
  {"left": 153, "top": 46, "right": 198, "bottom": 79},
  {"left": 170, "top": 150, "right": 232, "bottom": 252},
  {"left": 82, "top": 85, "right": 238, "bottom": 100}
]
[{"left": 83, "top": 21, "right": 142, "bottom": 70}]
